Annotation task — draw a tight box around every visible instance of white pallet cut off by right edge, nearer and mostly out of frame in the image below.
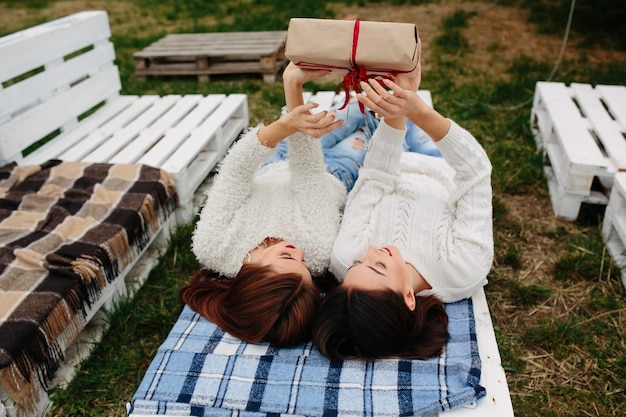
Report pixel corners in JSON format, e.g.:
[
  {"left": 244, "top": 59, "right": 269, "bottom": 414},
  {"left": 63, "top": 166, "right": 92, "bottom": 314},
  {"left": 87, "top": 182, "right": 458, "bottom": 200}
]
[{"left": 602, "top": 172, "right": 626, "bottom": 287}]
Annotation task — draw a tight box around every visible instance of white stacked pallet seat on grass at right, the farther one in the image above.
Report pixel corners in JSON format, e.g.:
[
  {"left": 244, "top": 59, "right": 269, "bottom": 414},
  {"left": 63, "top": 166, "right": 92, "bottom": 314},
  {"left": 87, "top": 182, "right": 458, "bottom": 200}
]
[{"left": 530, "top": 82, "right": 626, "bottom": 220}]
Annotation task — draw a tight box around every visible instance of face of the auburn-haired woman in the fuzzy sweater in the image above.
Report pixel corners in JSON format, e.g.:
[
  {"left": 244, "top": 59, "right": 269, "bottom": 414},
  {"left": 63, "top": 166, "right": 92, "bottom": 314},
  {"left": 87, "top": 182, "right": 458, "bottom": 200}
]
[{"left": 249, "top": 240, "right": 313, "bottom": 283}]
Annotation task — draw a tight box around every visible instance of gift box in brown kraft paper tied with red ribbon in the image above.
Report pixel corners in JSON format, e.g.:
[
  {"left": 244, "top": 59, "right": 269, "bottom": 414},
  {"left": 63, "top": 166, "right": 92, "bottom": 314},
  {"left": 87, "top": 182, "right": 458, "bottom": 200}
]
[{"left": 285, "top": 18, "right": 420, "bottom": 76}]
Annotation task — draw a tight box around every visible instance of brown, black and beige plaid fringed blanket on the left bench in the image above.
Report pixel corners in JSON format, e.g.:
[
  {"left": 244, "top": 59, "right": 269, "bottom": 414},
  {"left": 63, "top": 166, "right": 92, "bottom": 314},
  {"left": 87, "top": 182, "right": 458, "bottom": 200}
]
[{"left": 0, "top": 160, "right": 177, "bottom": 412}]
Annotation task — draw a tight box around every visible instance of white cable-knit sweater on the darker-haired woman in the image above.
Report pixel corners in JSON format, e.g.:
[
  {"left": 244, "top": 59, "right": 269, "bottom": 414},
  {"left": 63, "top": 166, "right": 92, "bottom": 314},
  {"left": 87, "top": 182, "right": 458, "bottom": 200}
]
[{"left": 330, "top": 121, "right": 493, "bottom": 302}]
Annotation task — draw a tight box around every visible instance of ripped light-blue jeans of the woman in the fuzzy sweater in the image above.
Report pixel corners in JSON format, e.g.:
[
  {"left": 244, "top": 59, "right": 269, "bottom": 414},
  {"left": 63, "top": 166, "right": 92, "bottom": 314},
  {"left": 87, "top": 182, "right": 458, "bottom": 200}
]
[{"left": 261, "top": 102, "right": 378, "bottom": 192}]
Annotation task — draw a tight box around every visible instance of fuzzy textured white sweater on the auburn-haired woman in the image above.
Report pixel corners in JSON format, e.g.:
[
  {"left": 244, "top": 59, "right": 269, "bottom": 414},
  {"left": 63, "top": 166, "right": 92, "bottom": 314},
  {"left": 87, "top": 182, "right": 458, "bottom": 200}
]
[{"left": 192, "top": 126, "right": 346, "bottom": 277}]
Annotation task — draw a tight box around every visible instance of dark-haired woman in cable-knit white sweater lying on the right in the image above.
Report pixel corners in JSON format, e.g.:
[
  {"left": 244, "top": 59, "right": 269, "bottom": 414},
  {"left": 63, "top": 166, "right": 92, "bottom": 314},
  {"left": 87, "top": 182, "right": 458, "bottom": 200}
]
[{"left": 313, "top": 49, "right": 493, "bottom": 359}]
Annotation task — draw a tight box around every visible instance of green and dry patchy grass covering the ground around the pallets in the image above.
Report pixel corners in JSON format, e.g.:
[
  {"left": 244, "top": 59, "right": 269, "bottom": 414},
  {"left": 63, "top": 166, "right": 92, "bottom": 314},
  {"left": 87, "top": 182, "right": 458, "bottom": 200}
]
[{"left": 0, "top": 0, "right": 626, "bottom": 417}]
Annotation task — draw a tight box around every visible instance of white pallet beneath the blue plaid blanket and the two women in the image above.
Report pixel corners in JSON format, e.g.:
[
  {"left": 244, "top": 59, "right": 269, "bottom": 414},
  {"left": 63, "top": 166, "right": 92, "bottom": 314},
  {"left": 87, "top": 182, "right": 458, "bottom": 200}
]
[{"left": 125, "top": 90, "right": 514, "bottom": 417}]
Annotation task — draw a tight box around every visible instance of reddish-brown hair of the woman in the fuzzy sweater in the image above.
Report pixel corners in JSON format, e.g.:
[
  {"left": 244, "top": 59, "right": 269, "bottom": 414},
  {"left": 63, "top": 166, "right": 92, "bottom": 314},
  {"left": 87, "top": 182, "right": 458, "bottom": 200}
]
[{"left": 178, "top": 264, "right": 320, "bottom": 346}]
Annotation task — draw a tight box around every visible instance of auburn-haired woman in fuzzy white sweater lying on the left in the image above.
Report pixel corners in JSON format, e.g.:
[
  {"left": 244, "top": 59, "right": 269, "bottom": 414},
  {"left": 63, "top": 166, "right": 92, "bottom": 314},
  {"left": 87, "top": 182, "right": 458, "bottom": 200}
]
[{"left": 179, "top": 65, "right": 347, "bottom": 346}]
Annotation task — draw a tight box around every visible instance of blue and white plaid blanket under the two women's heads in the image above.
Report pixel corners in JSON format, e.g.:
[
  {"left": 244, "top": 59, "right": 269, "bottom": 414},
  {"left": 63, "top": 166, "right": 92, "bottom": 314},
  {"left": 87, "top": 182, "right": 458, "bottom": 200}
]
[{"left": 129, "top": 299, "right": 485, "bottom": 417}]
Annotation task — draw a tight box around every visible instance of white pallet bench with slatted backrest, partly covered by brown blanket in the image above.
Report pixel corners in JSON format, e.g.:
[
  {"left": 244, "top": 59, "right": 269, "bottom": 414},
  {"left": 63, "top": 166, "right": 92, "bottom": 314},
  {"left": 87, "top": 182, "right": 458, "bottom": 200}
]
[{"left": 0, "top": 11, "right": 249, "bottom": 417}]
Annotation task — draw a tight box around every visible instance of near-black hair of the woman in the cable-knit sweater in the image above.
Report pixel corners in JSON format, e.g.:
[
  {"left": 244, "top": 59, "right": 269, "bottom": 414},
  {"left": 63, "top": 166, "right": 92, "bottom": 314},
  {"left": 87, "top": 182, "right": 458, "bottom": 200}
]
[{"left": 313, "top": 287, "right": 450, "bottom": 360}]
